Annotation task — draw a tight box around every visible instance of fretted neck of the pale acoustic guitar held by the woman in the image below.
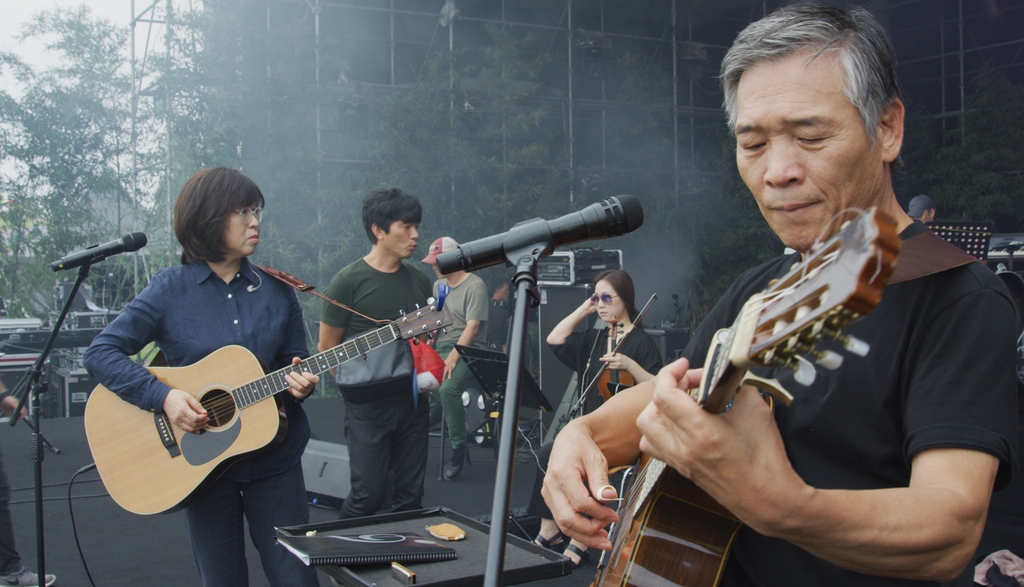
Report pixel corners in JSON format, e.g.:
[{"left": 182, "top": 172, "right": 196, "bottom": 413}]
[{"left": 231, "top": 324, "right": 401, "bottom": 408}]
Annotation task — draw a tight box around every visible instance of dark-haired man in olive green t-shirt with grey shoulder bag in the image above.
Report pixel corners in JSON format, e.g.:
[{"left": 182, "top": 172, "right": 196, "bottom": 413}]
[{"left": 317, "top": 188, "right": 430, "bottom": 518}]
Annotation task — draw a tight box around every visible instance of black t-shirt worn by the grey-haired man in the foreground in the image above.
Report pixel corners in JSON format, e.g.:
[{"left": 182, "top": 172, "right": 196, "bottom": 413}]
[{"left": 684, "top": 224, "right": 1018, "bottom": 587}]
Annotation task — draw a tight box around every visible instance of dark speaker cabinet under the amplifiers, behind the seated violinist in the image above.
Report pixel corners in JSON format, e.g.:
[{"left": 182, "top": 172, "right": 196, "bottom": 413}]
[{"left": 537, "top": 285, "right": 596, "bottom": 407}]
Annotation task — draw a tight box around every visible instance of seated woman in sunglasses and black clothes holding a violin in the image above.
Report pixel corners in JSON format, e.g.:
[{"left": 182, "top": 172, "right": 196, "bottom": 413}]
[{"left": 526, "top": 269, "right": 663, "bottom": 565}]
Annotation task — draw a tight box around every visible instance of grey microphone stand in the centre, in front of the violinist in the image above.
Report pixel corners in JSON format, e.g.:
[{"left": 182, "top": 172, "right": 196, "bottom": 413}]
[{"left": 483, "top": 243, "right": 551, "bottom": 587}]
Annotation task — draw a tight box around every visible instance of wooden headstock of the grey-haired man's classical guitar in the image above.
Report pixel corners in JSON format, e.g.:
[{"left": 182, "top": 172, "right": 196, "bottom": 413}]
[{"left": 695, "top": 209, "right": 901, "bottom": 409}]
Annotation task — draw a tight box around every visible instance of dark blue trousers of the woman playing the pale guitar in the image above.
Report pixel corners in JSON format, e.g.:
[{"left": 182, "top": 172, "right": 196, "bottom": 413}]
[{"left": 184, "top": 464, "right": 319, "bottom": 587}]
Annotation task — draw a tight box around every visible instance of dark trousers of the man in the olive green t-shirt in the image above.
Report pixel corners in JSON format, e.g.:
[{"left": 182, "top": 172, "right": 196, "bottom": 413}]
[{"left": 341, "top": 393, "right": 430, "bottom": 518}]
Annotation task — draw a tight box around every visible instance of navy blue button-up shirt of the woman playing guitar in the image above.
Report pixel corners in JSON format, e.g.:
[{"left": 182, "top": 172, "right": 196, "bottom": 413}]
[{"left": 85, "top": 259, "right": 309, "bottom": 481}]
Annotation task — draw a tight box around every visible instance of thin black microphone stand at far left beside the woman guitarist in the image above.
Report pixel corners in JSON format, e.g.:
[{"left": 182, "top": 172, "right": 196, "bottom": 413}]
[{"left": 10, "top": 263, "right": 92, "bottom": 584}]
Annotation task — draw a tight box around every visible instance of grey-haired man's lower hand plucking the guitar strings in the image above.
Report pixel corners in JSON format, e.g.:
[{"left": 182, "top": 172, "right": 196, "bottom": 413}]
[{"left": 541, "top": 421, "right": 618, "bottom": 550}]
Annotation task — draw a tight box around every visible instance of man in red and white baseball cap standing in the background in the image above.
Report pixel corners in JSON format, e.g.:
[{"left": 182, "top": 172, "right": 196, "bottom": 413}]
[{"left": 423, "top": 237, "right": 490, "bottom": 480}]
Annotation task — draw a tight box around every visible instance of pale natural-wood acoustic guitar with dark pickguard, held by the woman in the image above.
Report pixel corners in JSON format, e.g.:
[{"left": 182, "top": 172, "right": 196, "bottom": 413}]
[{"left": 79, "top": 302, "right": 452, "bottom": 514}]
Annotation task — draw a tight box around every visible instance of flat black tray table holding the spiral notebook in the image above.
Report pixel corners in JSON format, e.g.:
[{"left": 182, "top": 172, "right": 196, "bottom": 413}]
[{"left": 278, "top": 507, "right": 572, "bottom": 587}]
